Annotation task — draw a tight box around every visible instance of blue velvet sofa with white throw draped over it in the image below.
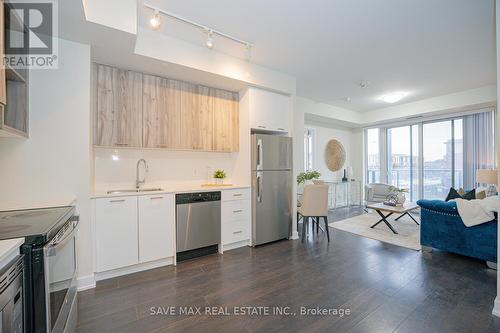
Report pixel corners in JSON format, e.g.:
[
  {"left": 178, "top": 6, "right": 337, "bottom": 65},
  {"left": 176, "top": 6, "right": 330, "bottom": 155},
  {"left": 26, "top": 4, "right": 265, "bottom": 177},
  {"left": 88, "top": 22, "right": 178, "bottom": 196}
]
[{"left": 417, "top": 200, "right": 497, "bottom": 266}]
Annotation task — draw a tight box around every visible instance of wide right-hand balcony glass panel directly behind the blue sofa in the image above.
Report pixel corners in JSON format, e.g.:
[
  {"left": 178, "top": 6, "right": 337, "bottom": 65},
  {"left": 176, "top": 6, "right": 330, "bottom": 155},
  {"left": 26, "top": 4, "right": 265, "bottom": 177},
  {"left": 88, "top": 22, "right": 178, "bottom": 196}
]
[{"left": 423, "top": 119, "right": 463, "bottom": 199}]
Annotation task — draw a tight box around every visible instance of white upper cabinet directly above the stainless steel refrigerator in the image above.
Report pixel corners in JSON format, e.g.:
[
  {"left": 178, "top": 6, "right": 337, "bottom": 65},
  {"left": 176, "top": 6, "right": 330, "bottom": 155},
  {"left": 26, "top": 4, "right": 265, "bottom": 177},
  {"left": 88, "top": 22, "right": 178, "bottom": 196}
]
[{"left": 248, "top": 88, "right": 292, "bottom": 133}]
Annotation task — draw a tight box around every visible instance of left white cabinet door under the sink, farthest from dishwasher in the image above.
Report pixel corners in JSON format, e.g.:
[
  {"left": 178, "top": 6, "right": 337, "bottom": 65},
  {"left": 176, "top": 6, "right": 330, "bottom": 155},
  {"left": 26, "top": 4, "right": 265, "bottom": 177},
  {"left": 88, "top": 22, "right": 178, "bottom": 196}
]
[{"left": 95, "top": 196, "right": 139, "bottom": 272}]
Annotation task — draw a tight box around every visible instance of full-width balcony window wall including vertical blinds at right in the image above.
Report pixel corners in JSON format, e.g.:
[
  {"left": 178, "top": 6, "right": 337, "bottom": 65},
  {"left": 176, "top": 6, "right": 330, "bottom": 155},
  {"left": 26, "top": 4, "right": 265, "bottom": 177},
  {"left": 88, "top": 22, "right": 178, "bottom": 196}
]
[{"left": 365, "top": 110, "right": 495, "bottom": 201}]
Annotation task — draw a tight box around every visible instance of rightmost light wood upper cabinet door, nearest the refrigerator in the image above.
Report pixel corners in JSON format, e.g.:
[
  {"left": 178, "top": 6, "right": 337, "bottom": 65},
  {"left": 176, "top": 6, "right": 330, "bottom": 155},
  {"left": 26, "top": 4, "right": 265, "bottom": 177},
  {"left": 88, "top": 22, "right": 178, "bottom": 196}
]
[{"left": 213, "top": 89, "right": 240, "bottom": 152}]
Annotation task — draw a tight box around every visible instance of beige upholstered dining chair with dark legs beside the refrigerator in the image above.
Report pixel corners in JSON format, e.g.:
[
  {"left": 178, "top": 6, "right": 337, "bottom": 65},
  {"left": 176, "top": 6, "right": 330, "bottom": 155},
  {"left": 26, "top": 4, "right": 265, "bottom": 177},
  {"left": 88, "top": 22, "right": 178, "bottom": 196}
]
[{"left": 297, "top": 184, "right": 330, "bottom": 242}]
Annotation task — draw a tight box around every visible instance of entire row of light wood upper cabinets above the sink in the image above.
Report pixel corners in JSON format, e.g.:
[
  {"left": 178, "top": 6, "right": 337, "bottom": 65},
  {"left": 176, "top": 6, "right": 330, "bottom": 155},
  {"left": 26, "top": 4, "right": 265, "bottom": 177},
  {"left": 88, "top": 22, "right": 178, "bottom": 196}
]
[{"left": 94, "top": 65, "right": 239, "bottom": 152}]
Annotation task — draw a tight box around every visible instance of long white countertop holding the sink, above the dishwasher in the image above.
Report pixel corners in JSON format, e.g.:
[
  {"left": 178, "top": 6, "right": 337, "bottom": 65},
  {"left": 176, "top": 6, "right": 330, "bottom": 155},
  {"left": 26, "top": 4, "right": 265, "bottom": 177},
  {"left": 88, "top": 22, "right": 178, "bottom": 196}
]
[{"left": 90, "top": 184, "right": 250, "bottom": 199}]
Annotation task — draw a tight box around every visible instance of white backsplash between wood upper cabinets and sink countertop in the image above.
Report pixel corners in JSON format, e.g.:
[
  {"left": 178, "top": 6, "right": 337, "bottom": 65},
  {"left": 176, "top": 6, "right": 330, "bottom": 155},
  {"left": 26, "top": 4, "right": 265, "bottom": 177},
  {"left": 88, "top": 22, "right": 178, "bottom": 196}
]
[{"left": 94, "top": 148, "right": 241, "bottom": 190}]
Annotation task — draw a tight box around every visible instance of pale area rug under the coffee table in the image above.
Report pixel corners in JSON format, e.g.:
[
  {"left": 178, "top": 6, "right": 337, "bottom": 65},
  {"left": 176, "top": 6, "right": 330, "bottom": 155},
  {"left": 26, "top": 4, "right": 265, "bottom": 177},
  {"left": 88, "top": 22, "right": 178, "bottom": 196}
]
[{"left": 329, "top": 212, "right": 420, "bottom": 251}]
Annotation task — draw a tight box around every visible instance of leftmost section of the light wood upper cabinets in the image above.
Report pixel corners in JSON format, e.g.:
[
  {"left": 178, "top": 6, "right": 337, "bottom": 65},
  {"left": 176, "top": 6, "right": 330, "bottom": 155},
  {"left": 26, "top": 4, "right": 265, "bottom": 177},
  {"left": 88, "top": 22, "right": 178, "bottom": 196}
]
[{"left": 94, "top": 65, "right": 142, "bottom": 147}]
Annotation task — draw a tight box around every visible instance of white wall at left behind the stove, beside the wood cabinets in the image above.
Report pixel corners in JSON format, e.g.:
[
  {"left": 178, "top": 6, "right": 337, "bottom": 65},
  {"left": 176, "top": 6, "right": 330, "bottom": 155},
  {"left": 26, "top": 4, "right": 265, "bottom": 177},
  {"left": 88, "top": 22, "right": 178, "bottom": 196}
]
[{"left": 0, "top": 40, "right": 92, "bottom": 276}]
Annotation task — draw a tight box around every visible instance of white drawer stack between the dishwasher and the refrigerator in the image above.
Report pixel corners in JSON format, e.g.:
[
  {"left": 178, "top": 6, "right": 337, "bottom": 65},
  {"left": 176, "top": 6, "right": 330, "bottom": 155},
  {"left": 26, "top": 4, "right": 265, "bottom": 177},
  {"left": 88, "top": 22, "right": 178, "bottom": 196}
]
[{"left": 221, "top": 189, "right": 252, "bottom": 250}]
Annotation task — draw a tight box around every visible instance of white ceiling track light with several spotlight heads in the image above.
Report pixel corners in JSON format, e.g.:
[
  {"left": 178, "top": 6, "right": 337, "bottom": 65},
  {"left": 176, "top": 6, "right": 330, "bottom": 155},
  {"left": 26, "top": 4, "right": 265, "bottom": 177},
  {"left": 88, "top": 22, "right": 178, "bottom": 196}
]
[{"left": 144, "top": 3, "right": 253, "bottom": 54}]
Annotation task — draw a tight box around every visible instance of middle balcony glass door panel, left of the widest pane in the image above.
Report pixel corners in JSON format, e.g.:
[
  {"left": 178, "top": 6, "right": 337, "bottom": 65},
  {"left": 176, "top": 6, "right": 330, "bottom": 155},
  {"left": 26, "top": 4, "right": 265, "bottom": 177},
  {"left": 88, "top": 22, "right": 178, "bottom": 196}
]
[{"left": 387, "top": 125, "right": 419, "bottom": 201}]
